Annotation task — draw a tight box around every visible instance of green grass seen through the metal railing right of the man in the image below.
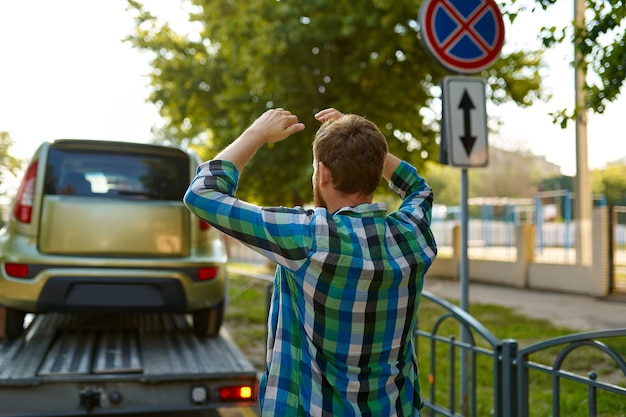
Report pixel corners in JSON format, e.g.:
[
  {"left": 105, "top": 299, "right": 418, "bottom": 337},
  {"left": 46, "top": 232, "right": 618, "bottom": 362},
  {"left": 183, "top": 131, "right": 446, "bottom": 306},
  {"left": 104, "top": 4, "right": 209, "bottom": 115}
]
[{"left": 418, "top": 300, "right": 626, "bottom": 417}]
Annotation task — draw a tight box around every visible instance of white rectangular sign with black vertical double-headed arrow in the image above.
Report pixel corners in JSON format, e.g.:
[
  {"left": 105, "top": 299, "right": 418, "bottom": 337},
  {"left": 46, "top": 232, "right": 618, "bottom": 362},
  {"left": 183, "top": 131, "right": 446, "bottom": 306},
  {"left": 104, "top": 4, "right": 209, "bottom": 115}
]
[{"left": 442, "top": 76, "right": 489, "bottom": 167}]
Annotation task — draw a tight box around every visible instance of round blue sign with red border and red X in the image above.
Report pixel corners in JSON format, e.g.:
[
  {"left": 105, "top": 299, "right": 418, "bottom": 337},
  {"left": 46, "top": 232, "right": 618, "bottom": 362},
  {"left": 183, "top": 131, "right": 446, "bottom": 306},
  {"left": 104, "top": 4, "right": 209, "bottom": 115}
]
[{"left": 419, "top": 0, "right": 504, "bottom": 73}]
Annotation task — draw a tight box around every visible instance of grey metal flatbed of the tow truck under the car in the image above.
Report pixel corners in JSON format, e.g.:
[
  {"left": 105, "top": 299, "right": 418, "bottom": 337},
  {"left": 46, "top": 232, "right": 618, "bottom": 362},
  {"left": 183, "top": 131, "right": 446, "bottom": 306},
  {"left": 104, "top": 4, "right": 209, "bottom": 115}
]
[{"left": 0, "top": 314, "right": 257, "bottom": 416}]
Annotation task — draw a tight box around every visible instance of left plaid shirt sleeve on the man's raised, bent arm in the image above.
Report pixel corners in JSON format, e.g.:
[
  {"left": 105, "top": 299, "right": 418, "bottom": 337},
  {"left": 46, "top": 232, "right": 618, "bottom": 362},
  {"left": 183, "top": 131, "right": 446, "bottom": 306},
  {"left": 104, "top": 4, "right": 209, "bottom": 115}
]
[{"left": 183, "top": 160, "right": 313, "bottom": 270}]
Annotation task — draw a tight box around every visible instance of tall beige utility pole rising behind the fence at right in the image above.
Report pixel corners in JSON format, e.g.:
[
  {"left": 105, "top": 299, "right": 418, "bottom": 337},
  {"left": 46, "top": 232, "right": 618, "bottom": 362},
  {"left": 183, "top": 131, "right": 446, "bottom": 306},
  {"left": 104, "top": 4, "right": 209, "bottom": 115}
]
[{"left": 574, "top": 0, "right": 593, "bottom": 266}]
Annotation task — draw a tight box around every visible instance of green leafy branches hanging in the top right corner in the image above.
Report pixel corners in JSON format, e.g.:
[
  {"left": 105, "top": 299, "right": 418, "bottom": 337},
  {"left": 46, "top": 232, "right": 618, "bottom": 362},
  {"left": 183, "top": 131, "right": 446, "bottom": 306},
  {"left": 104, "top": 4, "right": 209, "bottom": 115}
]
[{"left": 512, "top": 0, "right": 626, "bottom": 123}]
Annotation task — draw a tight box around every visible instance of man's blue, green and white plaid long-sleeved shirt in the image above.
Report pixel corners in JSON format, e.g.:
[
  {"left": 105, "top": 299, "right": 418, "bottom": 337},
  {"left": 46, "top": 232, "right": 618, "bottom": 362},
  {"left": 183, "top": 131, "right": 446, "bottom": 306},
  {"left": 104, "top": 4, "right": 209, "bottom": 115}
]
[{"left": 184, "top": 160, "right": 437, "bottom": 416}]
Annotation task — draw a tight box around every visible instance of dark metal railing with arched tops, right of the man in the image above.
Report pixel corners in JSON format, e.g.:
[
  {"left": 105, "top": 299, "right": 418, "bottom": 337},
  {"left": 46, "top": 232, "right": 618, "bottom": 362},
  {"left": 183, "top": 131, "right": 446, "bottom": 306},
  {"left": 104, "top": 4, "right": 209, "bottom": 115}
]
[{"left": 415, "top": 291, "right": 626, "bottom": 417}]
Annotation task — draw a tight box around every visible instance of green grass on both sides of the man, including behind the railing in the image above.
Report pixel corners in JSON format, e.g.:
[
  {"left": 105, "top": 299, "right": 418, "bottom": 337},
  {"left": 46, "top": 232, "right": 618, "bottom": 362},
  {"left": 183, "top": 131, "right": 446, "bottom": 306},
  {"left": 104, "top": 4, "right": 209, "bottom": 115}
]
[{"left": 225, "top": 264, "right": 626, "bottom": 417}]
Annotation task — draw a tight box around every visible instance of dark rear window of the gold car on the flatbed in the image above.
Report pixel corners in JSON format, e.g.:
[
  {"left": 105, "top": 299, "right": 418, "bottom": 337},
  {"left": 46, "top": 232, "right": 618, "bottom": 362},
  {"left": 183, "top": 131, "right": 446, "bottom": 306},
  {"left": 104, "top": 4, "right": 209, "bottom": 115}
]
[{"left": 44, "top": 147, "right": 190, "bottom": 201}]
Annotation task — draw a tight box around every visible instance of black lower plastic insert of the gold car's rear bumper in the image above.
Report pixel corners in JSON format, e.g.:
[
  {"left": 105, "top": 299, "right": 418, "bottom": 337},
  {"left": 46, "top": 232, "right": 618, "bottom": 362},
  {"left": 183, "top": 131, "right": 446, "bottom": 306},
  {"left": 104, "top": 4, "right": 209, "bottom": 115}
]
[{"left": 37, "top": 277, "right": 187, "bottom": 313}]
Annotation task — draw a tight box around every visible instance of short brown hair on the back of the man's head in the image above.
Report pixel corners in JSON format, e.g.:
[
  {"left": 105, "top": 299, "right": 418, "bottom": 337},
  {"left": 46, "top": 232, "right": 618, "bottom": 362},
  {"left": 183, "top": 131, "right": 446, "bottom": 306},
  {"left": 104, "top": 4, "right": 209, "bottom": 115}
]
[{"left": 313, "top": 114, "right": 387, "bottom": 195}]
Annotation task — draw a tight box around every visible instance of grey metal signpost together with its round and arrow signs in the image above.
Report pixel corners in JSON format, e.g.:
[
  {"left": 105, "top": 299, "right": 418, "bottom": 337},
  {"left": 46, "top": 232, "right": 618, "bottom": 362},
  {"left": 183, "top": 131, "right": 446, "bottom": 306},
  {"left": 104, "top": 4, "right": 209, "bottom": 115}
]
[{"left": 419, "top": 0, "right": 504, "bottom": 415}]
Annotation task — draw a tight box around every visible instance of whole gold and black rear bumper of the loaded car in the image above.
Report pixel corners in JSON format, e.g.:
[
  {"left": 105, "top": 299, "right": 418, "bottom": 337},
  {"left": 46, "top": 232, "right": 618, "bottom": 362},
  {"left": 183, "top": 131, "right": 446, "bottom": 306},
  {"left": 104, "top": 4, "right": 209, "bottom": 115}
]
[{"left": 0, "top": 257, "right": 228, "bottom": 313}]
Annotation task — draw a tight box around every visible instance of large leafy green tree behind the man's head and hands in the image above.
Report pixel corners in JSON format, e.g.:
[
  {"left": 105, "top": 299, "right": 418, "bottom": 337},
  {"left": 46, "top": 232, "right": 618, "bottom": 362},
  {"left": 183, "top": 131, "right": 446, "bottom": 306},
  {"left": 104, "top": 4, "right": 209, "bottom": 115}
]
[{"left": 129, "top": 0, "right": 541, "bottom": 204}]
